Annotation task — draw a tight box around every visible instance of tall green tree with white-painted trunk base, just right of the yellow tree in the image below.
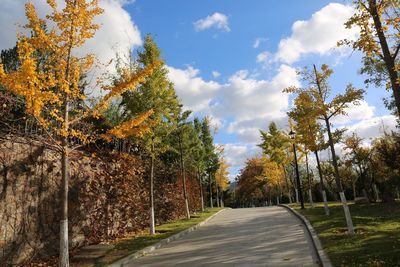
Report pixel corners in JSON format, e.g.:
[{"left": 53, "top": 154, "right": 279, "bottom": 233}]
[{"left": 121, "top": 35, "right": 181, "bottom": 234}]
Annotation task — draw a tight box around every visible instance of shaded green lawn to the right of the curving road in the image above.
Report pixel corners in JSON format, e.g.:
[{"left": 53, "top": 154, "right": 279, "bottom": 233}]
[{"left": 292, "top": 202, "right": 400, "bottom": 267}]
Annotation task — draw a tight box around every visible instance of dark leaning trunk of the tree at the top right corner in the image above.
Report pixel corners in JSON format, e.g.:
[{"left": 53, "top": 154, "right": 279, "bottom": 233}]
[{"left": 368, "top": 0, "right": 400, "bottom": 117}]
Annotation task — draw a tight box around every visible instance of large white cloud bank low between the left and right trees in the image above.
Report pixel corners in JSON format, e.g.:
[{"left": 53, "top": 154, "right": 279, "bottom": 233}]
[{"left": 169, "top": 65, "right": 299, "bottom": 143}]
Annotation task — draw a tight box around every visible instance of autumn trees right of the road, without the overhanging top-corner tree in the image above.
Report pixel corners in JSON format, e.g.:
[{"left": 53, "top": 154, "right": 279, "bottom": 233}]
[{"left": 236, "top": 62, "right": 400, "bottom": 237}]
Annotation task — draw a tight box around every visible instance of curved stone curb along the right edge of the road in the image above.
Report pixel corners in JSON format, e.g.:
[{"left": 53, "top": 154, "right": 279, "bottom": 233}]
[{"left": 278, "top": 204, "right": 332, "bottom": 267}]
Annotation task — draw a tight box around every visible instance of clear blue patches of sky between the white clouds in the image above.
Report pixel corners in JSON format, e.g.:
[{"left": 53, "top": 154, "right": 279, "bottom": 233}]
[{"left": 126, "top": 0, "right": 396, "bottom": 180}]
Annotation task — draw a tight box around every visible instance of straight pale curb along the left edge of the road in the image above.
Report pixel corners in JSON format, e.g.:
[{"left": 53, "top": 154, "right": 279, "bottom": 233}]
[{"left": 107, "top": 208, "right": 230, "bottom": 267}]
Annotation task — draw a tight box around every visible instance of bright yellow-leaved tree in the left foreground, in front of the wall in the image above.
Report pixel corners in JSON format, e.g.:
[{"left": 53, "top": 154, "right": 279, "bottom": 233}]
[{"left": 0, "top": 0, "right": 156, "bottom": 267}]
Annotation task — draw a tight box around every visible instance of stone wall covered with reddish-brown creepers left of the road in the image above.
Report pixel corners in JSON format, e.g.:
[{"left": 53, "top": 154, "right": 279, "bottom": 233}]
[{"left": 0, "top": 136, "right": 200, "bottom": 266}]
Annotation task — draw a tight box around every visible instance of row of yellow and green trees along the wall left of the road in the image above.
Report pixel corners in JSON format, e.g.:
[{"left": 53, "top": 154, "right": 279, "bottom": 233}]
[{"left": 0, "top": 0, "right": 228, "bottom": 266}]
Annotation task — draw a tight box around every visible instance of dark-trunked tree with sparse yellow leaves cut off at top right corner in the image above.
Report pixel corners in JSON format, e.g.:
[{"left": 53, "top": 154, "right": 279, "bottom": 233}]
[{"left": 338, "top": 0, "right": 400, "bottom": 116}]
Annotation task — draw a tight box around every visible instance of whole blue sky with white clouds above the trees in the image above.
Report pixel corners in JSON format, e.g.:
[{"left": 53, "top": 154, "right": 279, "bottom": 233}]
[{"left": 0, "top": 0, "right": 395, "bottom": 180}]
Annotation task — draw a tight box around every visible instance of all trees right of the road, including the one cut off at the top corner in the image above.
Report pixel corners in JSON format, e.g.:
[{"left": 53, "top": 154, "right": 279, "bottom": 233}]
[{"left": 234, "top": 0, "right": 400, "bottom": 238}]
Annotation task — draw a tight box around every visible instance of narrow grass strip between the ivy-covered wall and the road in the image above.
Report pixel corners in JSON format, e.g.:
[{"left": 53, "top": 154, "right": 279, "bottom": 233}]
[{"left": 71, "top": 208, "right": 221, "bottom": 267}]
